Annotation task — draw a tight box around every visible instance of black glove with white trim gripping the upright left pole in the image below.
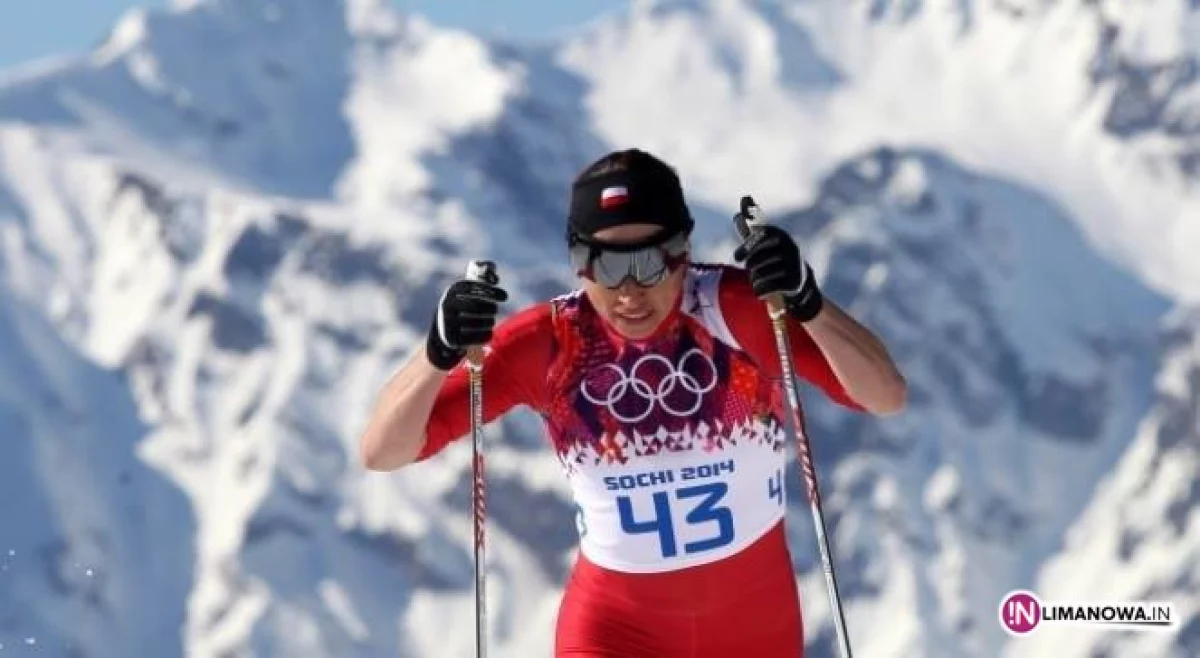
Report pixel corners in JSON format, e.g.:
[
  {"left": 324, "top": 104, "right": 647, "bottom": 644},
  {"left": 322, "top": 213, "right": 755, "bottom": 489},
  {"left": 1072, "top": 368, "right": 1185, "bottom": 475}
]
[{"left": 425, "top": 279, "right": 509, "bottom": 370}]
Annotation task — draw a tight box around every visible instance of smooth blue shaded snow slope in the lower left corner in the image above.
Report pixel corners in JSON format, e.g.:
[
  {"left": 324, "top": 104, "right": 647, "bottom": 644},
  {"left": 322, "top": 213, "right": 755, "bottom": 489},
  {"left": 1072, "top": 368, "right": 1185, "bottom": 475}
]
[{"left": 0, "top": 286, "right": 196, "bottom": 658}]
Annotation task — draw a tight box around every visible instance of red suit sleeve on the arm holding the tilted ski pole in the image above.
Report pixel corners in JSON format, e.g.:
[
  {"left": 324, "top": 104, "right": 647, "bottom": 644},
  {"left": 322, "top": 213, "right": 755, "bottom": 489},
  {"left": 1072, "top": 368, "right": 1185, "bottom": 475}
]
[{"left": 719, "top": 268, "right": 864, "bottom": 411}]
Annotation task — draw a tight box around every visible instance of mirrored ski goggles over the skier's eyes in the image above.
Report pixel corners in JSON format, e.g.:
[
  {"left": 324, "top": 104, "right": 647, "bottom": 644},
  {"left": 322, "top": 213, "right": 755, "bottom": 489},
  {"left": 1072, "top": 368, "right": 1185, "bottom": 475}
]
[{"left": 570, "top": 232, "right": 688, "bottom": 288}]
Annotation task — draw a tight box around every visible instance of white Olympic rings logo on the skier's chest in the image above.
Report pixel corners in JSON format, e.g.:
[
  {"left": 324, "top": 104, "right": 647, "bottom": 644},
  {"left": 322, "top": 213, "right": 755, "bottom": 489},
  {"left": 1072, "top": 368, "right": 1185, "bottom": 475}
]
[{"left": 580, "top": 347, "right": 716, "bottom": 423}]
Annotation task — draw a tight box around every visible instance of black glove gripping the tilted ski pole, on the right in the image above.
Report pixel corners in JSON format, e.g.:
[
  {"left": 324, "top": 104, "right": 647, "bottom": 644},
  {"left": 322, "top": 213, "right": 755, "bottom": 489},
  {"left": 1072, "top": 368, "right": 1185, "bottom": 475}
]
[{"left": 733, "top": 225, "right": 822, "bottom": 322}]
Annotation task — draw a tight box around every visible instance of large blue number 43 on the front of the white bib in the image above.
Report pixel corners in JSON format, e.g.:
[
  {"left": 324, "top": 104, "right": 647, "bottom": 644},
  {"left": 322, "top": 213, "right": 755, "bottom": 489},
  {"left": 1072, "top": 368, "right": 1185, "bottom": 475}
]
[{"left": 617, "top": 481, "right": 733, "bottom": 557}]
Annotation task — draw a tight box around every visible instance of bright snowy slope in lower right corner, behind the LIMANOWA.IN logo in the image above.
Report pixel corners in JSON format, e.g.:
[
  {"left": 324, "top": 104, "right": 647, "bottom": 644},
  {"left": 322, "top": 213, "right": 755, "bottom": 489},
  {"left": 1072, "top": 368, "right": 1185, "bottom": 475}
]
[{"left": 1010, "top": 309, "right": 1200, "bottom": 658}]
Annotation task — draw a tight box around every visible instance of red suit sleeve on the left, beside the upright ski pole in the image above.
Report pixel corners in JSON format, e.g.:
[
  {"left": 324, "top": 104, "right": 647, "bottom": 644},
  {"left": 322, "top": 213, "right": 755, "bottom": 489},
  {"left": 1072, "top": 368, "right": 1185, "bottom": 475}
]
[{"left": 416, "top": 303, "right": 553, "bottom": 461}]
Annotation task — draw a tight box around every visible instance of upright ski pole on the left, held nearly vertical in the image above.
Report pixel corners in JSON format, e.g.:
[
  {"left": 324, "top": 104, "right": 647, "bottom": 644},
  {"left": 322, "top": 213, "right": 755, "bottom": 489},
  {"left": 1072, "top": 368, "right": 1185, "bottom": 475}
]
[{"left": 467, "top": 261, "right": 499, "bottom": 658}]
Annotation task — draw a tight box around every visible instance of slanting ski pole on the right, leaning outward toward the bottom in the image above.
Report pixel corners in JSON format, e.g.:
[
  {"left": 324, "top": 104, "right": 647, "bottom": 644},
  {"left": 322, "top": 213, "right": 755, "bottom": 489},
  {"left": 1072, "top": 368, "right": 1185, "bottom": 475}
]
[{"left": 733, "top": 196, "right": 851, "bottom": 658}]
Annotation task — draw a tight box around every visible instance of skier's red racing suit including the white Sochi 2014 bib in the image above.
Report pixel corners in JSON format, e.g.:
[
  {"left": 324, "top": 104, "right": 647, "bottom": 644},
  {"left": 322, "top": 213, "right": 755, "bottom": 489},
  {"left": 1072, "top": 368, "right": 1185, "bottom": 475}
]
[{"left": 418, "top": 264, "right": 862, "bottom": 658}]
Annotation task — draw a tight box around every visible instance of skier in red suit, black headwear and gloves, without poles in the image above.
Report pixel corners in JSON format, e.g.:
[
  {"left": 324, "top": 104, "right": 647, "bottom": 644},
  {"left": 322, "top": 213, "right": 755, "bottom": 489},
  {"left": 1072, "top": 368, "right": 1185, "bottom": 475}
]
[{"left": 361, "top": 149, "right": 907, "bottom": 658}]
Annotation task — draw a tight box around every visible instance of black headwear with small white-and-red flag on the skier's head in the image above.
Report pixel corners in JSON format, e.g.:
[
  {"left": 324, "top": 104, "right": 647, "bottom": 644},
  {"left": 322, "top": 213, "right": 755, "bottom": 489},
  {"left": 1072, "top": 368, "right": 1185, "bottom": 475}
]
[{"left": 568, "top": 149, "right": 695, "bottom": 239}]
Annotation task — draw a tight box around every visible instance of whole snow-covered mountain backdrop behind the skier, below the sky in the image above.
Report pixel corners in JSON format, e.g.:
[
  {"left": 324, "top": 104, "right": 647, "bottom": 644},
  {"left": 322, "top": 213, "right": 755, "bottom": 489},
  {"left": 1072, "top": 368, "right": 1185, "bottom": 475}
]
[{"left": 0, "top": 0, "right": 1200, "bottom": 658}]
